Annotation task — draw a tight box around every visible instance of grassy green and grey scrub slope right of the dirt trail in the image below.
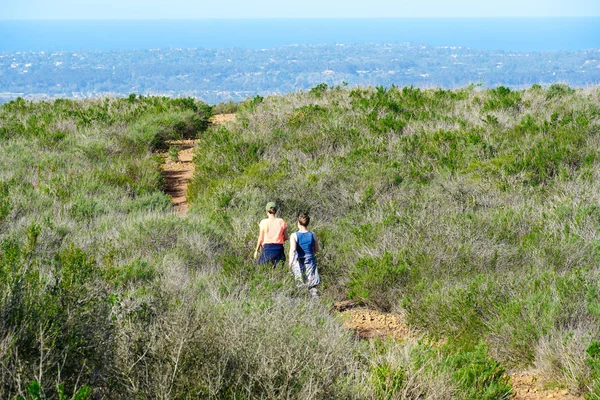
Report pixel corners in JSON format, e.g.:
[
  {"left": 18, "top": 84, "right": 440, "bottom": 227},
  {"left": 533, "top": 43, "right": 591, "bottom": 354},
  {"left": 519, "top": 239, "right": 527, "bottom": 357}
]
[{"left": 189, "top": 85, "right": 600, "bottom": 391}]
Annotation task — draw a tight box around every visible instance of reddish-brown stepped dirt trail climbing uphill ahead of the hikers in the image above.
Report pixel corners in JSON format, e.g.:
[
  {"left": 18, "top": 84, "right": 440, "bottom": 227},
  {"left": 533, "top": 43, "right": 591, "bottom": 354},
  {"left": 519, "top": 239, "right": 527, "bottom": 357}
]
[{"left": 161, "top": 114, "right": 235, "bottom": 216}]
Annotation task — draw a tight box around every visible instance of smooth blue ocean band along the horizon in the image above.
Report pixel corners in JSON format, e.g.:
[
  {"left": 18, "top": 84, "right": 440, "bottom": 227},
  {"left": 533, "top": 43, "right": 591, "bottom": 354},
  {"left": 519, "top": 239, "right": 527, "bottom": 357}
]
[{"left": 0, "top": 17, "right": 600, "bottom": 52}]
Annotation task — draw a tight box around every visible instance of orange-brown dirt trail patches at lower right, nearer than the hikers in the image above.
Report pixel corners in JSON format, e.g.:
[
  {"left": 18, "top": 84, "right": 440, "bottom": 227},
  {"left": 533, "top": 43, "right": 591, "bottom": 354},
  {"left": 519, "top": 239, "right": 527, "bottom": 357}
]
[{"left": 334, "top": 300, "right": 583, "bottom": 400}]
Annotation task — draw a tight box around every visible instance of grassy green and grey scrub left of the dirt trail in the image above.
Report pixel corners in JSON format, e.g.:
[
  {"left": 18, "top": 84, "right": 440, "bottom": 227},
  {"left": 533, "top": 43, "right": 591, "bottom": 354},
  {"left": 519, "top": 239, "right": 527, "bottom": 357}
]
[{"left": 0, "top": 95, "right": 458, "bottom": 399}]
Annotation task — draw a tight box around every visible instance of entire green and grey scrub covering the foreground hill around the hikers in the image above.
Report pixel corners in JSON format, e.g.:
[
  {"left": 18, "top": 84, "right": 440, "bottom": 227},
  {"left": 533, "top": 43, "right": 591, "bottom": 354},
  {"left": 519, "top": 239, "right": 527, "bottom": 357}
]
[{"left": 0, "top": 85, "right": 600, "bottom": 399}]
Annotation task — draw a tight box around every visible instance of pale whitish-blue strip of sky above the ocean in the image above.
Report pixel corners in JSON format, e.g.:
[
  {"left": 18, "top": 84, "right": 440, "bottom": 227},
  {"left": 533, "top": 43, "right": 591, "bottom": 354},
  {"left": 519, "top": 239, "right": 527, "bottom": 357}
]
[{"left": 0, "top": 0, "right": 600, "bottom": 20}]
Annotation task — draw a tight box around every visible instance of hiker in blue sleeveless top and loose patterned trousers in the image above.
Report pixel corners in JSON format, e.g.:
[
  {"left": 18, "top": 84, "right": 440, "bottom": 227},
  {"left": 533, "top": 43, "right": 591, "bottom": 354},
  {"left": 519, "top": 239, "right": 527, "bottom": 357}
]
[{"left": 289, "top": 213, "right": 320, "bottom": 298}]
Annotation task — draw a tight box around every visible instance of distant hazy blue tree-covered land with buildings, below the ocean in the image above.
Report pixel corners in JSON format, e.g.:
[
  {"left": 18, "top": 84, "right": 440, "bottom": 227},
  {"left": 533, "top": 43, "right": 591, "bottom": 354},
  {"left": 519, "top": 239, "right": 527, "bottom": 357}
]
[{"left": 0, "top": 43, "right": 600, "bottom": 103}]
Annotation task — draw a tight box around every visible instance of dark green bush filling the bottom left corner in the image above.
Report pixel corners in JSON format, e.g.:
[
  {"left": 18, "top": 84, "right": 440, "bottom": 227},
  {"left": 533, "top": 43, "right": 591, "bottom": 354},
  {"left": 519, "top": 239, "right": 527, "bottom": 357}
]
[{"left": 0, "top": 242, "right": 114, "bottom": 398}]
